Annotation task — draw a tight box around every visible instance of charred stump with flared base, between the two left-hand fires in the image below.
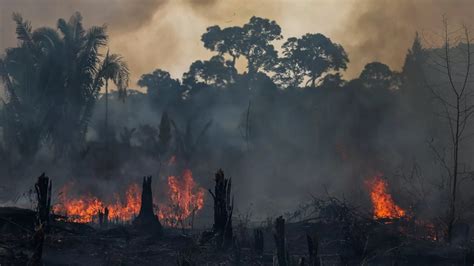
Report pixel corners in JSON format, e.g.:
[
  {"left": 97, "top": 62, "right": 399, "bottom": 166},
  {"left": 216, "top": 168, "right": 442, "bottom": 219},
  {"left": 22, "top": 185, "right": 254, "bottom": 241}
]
[{"left": 133, "top": 176, "right": 163, "bottom": 234}]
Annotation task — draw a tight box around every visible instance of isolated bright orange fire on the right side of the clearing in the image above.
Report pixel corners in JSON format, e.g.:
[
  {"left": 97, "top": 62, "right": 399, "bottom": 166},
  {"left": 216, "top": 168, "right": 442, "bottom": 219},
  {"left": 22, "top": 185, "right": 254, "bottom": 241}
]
[{"left": 367, "top": 175, "right": 406, "bottom": 219}]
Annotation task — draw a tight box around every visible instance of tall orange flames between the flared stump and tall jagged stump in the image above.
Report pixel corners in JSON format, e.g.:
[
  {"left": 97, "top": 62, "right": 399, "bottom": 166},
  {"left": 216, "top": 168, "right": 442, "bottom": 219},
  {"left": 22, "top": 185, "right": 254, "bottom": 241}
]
[{"left": 158, "top": 169, "right": 204, "bottom": 227}]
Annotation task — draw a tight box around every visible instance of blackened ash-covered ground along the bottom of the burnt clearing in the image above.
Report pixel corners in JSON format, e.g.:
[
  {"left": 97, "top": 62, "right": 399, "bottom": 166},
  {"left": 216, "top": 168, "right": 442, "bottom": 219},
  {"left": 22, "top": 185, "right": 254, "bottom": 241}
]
[{"left": 0, "top": 208, "right": 474, "bottom": 266}]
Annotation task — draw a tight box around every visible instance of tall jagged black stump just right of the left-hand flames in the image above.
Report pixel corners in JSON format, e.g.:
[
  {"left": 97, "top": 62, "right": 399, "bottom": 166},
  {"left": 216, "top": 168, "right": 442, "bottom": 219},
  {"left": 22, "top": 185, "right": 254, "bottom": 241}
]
[{"left": 209, "top": 169, "right": 234, "bottom": 248}]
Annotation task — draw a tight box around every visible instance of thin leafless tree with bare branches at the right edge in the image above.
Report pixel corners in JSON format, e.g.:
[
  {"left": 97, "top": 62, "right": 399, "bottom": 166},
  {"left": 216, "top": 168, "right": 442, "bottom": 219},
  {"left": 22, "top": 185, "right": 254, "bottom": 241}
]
[{"left": 428, "top": 19, "right": 474, "bottom": 240}]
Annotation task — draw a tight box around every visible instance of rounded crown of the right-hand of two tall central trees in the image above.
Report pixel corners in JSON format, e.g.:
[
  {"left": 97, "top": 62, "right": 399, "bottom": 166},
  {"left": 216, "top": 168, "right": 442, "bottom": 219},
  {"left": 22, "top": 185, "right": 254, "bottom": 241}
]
[{"left": 276, "top": 33, "right": 349, "bottom": 87}]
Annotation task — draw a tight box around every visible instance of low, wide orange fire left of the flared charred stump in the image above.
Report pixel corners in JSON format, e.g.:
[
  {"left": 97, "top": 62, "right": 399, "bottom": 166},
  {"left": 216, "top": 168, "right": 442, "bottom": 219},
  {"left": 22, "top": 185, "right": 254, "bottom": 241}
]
[{"left": 53, "top": 184, "right": 140, "bottom": 223}]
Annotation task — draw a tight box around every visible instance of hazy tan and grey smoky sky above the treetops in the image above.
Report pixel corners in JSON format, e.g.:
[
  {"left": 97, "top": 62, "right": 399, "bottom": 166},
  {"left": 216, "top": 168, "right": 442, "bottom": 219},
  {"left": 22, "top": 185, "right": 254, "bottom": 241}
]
[{"left": 0, "top": 0, "right": 474, "bottom": 87}]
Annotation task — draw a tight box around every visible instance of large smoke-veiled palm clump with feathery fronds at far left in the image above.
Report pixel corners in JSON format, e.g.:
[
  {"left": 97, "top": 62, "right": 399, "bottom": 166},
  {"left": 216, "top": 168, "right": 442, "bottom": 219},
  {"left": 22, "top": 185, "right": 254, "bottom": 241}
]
[{"left": 0, "top": 12, "right": 129, "bottom": 159}]
